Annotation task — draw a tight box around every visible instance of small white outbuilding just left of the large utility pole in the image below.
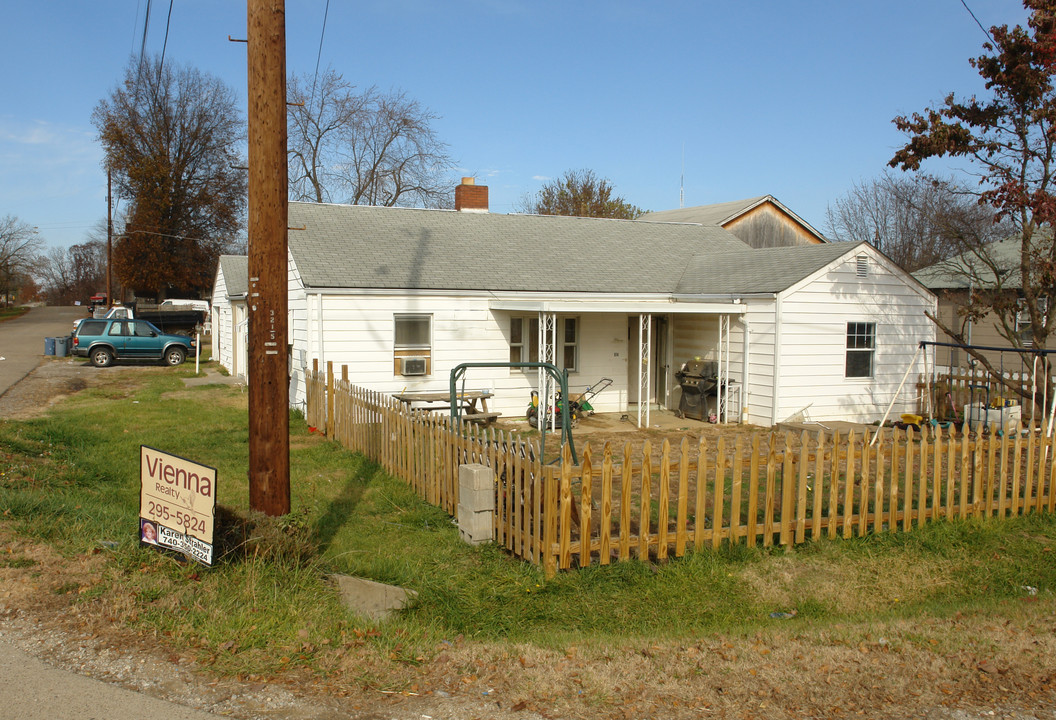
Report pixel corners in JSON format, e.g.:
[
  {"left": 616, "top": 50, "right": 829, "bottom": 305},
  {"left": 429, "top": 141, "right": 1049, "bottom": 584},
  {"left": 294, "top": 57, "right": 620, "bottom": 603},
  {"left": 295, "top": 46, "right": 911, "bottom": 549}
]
[{"left": 212, "top": 255, "right": 249, "bottom": 379}]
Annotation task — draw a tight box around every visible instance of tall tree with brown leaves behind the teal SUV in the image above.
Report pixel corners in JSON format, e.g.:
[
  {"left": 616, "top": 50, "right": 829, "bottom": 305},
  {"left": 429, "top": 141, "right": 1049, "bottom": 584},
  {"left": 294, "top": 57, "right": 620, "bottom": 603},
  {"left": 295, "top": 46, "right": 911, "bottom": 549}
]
[{"left": 92, "top": 54, "right": 247, "bottom": 296}]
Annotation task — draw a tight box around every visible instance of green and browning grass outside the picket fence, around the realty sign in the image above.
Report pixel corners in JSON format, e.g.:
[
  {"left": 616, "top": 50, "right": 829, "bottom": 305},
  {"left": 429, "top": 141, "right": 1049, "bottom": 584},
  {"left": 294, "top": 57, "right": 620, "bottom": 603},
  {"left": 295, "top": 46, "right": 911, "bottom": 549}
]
[{"left": 0, "top": 364, "right": 1056, "bottom": 708}]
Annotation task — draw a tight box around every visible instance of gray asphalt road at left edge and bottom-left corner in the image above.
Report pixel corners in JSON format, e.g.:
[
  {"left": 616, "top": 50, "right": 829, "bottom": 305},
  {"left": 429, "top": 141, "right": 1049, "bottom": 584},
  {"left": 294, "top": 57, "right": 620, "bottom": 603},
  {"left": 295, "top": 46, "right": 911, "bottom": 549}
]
[{"left": 0, "top": 307, "right": 229, "bottom": 720}]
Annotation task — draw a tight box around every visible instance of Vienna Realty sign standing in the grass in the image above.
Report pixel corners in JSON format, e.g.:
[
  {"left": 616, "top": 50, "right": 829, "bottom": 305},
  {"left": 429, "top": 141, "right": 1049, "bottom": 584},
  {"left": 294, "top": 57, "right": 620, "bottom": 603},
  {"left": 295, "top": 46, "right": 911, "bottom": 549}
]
[{"left": 139, "top": 446, "right": 216, "bottom": 565}]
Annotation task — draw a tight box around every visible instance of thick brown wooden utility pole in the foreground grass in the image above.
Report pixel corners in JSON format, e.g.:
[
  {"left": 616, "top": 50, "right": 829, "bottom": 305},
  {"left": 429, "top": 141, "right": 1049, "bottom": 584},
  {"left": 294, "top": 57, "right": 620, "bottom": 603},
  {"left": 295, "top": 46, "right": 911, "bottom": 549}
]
[{"left": 241, "top": 0, "right": 289, "bottom": 516}]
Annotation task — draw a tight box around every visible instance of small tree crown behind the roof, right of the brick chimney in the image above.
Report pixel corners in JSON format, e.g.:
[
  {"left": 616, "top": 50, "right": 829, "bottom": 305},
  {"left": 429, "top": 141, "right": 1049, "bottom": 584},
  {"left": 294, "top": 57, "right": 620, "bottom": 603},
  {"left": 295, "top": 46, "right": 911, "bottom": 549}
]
[{"left": 518, "top": 170, "right": 643, "bottom": 220}]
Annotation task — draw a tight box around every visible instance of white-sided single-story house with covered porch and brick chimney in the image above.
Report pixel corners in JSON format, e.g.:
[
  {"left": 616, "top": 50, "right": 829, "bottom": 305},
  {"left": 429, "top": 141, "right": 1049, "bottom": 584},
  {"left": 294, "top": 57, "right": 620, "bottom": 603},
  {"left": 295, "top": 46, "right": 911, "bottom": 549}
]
[{"left": 213, "top": 180, "right": 935, "bottom": 425}]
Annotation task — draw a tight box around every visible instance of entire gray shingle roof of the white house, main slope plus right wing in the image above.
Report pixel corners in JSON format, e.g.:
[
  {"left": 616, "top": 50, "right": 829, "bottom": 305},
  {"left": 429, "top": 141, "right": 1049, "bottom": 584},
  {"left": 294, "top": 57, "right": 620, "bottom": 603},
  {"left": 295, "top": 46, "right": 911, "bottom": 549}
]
[{"left": 289, "top": 203, "right": 849, "bottom": 293}]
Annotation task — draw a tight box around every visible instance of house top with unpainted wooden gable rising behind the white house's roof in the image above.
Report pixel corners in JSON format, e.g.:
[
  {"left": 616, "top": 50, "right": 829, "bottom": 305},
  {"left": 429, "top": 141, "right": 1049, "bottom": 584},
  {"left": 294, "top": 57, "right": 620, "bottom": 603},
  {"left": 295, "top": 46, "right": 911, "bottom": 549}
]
[{"left": 640, "top": 195, "right": 828, "bottom": 248}]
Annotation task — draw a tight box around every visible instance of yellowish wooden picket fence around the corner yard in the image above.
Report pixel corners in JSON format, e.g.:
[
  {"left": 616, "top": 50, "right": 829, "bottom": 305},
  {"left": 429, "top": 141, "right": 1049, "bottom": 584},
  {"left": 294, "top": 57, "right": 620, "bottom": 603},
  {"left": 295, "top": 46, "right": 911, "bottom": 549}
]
[{"left": 306, "top": 361, "right": 1056, "bottom": 575}]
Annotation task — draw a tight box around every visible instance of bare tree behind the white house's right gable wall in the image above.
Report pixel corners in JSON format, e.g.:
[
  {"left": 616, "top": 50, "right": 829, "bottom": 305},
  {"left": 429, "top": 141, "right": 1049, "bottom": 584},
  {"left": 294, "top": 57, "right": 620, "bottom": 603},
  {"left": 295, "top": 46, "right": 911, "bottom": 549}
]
[{"left": 826, "top": 172, "right": 1013, "bottom": 272}]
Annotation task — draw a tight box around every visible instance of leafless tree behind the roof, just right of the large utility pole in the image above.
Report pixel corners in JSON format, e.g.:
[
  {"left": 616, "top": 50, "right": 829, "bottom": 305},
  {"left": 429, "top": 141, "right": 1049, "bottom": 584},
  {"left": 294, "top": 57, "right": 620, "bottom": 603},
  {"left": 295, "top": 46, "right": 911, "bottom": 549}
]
[{"left": 286, "top": 69, "right": 455, "bottom": 207}]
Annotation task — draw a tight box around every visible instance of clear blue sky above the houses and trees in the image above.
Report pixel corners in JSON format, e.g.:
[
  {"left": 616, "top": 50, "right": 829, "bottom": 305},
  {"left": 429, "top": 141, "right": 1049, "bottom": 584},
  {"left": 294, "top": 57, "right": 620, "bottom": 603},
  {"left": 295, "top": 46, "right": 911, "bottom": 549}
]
[{"left": 0, "top": 0, "right": 1025, "bottom": 245}]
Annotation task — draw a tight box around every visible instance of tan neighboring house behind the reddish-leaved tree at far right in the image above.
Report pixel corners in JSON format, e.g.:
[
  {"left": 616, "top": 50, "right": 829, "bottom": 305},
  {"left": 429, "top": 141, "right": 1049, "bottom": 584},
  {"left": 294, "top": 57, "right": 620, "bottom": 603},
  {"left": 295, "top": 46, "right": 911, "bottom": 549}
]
[{"left": 913, "top": 238, "right": 1030, "bottom": 371}]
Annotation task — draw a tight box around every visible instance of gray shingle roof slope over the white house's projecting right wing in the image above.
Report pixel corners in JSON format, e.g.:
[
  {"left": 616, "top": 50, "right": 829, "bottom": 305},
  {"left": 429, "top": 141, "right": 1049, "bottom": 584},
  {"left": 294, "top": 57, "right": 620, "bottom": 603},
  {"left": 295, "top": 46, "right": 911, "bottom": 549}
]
[{"left": 677, "top": 243, "right": 862, "bottom": 295}]
